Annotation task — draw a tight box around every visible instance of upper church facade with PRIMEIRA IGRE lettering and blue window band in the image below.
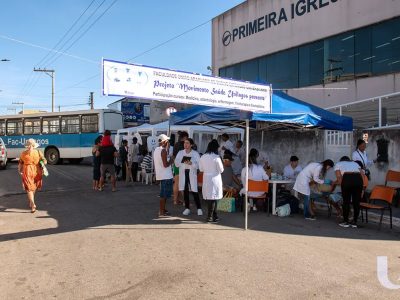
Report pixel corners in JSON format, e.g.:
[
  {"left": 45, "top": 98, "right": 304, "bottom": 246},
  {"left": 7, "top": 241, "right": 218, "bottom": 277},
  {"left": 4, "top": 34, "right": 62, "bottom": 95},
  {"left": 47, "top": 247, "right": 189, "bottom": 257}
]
[{"left": 212, "top": 0, "right": 400, "bottom": 108}]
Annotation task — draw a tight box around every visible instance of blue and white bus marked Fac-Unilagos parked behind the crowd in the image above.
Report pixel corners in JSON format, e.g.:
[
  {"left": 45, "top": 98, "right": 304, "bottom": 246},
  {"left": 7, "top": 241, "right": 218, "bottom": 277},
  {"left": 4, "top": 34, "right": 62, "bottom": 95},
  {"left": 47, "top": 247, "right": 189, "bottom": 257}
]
[{"left": 0, "top": 109, "right": 123, "bottom": 164}]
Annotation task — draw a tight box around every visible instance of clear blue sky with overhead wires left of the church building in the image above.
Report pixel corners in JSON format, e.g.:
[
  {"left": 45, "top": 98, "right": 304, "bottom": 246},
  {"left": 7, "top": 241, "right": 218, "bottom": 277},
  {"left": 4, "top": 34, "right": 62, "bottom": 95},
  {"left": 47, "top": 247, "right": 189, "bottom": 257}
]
[{"left": 0, "top": 0, "right": 243, "bottom": 114}]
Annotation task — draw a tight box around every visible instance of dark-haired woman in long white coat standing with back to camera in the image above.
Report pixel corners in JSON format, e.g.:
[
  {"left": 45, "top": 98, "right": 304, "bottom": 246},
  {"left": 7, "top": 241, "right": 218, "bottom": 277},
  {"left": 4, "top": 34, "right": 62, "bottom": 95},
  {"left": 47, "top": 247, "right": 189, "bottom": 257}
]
[{"left": 199, "top": 139, "right": 224, "bottom": 223}]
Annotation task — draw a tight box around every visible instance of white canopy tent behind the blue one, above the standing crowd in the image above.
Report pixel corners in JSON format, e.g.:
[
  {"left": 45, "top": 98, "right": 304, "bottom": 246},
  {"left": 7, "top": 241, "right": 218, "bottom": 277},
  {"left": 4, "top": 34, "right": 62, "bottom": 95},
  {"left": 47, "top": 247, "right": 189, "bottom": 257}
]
[{"left": 115, "top": 121, "right": 244, "bottom": 153}]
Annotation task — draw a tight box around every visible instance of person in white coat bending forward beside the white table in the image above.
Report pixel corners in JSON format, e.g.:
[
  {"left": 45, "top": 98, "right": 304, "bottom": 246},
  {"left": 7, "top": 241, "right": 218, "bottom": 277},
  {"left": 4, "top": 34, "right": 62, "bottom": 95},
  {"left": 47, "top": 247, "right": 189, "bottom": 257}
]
[{"left": 293, "top": 159, "right": 334, "bottom": 220}]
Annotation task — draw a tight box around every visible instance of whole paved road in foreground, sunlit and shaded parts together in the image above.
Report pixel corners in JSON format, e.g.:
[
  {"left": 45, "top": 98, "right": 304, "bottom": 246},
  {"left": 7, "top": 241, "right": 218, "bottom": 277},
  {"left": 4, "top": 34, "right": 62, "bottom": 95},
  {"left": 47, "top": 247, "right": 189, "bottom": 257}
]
[{"left": 0, "top": 165, "right": 400, "bottom": 299}]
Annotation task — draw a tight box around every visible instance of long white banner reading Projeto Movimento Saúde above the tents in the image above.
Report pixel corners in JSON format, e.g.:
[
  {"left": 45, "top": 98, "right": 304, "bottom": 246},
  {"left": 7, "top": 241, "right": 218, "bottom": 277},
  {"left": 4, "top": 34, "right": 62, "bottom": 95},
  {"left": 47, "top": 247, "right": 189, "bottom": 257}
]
[{"left": 103, "top": 60, "right": 271, "bottom": 112}]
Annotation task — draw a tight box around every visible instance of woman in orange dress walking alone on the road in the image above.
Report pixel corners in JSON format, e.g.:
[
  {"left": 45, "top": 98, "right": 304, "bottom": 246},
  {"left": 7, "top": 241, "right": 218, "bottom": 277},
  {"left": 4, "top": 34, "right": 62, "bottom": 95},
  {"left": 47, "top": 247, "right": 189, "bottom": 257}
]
[{"left": 18, "top": 139, "right": 47, "bottom": 213}]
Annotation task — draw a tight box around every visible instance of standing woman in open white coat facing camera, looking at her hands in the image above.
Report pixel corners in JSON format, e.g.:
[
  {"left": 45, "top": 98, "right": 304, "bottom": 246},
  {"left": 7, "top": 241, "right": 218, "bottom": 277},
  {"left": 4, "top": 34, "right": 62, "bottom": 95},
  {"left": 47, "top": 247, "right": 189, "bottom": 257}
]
[{"left": 175, "top": 138, "right": 203, "bottom": 216}]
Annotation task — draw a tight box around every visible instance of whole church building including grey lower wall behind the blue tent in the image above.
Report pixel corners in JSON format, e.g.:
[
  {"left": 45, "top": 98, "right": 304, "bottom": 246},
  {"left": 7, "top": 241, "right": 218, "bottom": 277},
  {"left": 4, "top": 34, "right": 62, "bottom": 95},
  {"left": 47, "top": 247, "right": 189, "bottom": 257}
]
[{"left": 211, "top": 0, "right": 400, "bottom": 186}]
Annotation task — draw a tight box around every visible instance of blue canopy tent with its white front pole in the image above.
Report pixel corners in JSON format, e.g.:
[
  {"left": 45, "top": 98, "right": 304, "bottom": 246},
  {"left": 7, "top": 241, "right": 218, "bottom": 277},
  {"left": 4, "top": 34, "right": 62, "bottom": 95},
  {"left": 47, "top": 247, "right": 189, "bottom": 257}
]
[{"left": 169, "top": 91, "right": 353, "bottom": 230}]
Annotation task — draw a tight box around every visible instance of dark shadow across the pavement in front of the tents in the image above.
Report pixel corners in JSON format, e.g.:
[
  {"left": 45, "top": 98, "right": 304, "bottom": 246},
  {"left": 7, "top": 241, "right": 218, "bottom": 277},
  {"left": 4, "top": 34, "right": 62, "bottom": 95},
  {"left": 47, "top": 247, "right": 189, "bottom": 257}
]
[{"left": 0, "top": 183, "right": 400, "bottom": 242}]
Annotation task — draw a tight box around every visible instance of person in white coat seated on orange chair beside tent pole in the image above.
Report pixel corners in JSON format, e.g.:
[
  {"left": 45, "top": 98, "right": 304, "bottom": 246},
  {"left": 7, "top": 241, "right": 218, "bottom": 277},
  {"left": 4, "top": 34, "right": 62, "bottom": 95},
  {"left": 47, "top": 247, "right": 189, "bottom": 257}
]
[{"left": 240, "top": 148, "right": 269, "bottom": 211}]
